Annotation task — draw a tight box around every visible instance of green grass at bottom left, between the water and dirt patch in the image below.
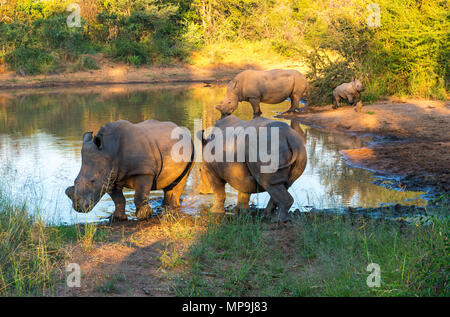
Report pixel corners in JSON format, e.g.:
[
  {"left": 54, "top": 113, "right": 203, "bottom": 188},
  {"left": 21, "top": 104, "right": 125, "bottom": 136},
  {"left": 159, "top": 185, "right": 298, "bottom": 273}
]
[{"left": 0, "top": 191, "right": 107, "bottom": 296}]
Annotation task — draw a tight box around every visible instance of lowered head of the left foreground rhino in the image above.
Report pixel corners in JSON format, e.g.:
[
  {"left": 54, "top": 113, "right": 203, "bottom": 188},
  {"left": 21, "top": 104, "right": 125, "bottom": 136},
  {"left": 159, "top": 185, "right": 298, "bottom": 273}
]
[{"left": 66, "top": 132, "right": 117, "bottom": 212}]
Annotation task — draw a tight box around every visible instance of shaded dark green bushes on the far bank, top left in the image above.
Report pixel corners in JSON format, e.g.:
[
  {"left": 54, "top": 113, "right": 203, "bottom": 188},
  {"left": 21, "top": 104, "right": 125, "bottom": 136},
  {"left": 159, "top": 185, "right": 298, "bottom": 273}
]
[{"left": 0, "top": 0, "right": 188, "bottom": 74}]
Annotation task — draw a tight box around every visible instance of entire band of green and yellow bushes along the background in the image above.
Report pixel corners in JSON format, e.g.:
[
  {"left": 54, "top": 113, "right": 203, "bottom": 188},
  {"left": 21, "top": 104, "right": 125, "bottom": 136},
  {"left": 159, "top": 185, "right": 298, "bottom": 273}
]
[{"left": 0, "top": 0, "right": 450, "bottom": 104}]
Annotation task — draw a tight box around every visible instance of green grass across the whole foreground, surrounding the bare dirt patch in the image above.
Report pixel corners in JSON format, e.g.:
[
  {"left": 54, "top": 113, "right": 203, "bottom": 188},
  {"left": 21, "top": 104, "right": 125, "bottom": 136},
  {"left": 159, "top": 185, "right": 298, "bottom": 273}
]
[{"left": 0, "top": 190, "right": 450, "bottom": 296}]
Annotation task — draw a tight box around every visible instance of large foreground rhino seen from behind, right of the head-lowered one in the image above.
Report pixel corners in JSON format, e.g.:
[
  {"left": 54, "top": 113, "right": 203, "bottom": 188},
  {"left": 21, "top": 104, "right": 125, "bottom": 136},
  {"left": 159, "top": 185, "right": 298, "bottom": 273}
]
[{"left": 200, "top": 116, "right": 306, "bottom": 221}]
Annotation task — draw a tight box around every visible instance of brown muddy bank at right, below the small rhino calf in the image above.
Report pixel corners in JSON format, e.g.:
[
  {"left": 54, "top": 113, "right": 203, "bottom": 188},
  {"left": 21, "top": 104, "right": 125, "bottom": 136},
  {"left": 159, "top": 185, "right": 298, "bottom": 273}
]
[{"left": 284, "top": 98, "right": 450, "bottom": 194}]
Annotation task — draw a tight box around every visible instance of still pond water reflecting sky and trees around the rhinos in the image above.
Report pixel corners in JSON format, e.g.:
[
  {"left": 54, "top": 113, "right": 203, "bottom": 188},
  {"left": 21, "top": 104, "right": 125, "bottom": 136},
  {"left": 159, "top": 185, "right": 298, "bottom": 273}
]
[{"left": 0, "top": 84, "right": 425, "bottom": 224}]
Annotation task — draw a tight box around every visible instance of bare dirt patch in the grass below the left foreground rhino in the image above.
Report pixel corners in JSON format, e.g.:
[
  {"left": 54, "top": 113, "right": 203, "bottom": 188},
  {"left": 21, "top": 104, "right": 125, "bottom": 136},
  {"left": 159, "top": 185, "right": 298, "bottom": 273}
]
[{"left": 56, "top": 218, "right": 183, "bottom": 297}]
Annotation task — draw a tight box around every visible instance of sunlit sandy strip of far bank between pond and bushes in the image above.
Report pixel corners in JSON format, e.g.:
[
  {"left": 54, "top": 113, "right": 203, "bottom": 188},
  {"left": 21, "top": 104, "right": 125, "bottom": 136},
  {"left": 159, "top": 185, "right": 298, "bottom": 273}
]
[{"left": 0, "top": 54, "right": 303, "bottom": 90}]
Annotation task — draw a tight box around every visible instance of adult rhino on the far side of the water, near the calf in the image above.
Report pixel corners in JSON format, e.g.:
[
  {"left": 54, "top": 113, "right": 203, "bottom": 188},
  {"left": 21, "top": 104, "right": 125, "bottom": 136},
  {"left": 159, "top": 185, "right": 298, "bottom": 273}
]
[{"left": 216, "top": 69, "right": 308, "bottom": 118}]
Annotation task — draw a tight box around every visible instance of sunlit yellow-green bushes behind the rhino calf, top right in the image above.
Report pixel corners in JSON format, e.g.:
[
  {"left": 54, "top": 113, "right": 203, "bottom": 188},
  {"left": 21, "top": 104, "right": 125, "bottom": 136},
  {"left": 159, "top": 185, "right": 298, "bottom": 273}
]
[{"left": 305, "top": 1, "right": 450, "bottom": 104}]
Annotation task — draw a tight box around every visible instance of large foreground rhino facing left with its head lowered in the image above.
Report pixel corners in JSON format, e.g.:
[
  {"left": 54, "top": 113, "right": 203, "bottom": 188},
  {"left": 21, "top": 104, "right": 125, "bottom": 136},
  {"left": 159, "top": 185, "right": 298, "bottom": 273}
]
[{"left": 66, "top": 120, "right": 193, "bottom": 221}]
